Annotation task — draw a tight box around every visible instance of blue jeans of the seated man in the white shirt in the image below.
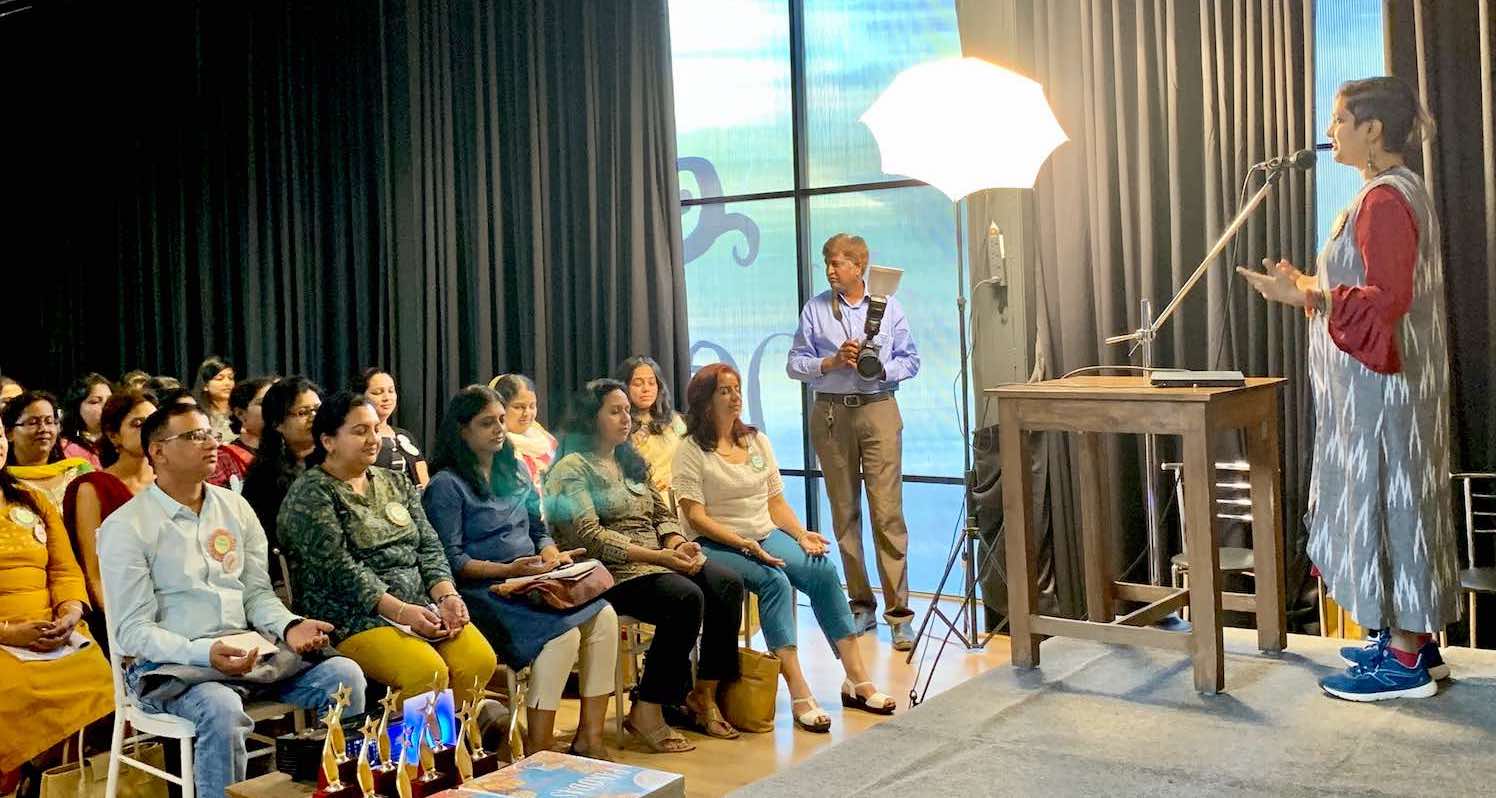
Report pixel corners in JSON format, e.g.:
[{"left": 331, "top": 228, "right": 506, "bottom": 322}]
[{"left": 141, "top": 657, "right": 365, "bottom": 798}]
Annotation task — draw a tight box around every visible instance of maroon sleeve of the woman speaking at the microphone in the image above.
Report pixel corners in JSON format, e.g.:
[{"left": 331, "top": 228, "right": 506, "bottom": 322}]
[{"left": 1330, "top": 186, "right": 1418, "bottom": 374}]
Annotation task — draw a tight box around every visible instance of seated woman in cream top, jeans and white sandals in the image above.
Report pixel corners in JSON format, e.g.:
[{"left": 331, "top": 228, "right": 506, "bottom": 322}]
[{"left": 675, "top": 364, "right": 895, "bottom": 732}]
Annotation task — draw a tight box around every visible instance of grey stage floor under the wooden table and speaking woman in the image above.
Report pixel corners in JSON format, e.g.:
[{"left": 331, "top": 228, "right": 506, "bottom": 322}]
[{"left": 733, "top": 629, "right": 1496, "bottom": 798}]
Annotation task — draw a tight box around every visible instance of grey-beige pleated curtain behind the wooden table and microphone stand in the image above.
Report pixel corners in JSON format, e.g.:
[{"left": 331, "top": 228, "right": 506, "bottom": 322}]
[{"left": 962, "top": 0, "right": 1313, "bottom": 614}]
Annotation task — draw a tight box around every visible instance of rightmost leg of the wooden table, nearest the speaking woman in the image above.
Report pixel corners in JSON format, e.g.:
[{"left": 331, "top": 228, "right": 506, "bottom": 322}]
[{"left": 1246, "top": 407, "right": 1288, "bottom": 653}]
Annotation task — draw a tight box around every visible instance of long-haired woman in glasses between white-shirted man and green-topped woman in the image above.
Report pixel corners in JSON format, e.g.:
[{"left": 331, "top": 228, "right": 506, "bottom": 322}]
[{"left": 244, "top": 376, "right": 322, "bottom": 553}]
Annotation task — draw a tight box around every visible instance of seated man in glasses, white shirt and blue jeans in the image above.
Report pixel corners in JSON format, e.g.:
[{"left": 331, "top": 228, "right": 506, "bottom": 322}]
[{"left": 99, "top": 403, "right": 365, "bottom": 797}]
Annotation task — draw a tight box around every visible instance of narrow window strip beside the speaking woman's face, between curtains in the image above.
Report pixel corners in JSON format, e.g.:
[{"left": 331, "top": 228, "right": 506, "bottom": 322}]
[{"left": 1306, "top": 0, "right": 1387, "bottom": 245}]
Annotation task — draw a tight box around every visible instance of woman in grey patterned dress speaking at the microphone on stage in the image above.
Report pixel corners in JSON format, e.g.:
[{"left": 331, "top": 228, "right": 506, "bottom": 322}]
[{"left": 1237, "top": 78, "right": 1460, "bottom": 701}]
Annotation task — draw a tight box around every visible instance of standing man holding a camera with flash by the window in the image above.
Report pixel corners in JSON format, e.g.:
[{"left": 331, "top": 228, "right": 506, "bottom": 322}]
[{"left": 785, "top": 232, "right": 920, "bottom": 651}]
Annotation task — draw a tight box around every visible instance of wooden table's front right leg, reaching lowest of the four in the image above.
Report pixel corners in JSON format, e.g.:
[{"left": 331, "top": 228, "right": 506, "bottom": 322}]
[{"left": 1183, "top": 422, "right": 1225, "bottom": 693}]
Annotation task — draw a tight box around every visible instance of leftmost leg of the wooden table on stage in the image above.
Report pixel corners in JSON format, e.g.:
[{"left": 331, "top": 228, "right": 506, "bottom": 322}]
[{"left": 998, "top": 400, "right": 1040, "bottom": 668}]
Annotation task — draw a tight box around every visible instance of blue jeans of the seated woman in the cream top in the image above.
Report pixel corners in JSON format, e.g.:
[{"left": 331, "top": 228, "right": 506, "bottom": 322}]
[{"left": 697, "top": 530, "right": 856, "bottom": 651}]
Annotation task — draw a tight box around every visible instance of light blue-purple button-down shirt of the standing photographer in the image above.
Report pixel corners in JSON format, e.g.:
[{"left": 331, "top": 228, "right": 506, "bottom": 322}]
[{"left": 785, "top": 290, "right": 920, "bottom": 394}]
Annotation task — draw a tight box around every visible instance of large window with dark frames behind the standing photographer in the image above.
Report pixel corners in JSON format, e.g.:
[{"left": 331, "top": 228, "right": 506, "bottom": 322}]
[{"left": 670, "top": 0, "right": 962, "bottom": 591}]
